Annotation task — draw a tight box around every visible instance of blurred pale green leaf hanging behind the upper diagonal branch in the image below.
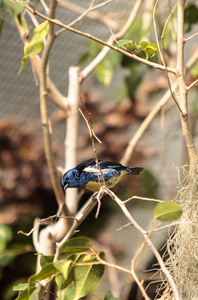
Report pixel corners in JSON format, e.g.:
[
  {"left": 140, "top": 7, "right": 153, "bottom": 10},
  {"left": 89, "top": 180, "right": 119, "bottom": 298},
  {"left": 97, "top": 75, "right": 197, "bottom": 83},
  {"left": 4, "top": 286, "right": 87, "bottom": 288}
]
[{"left": 96, "top": 58, "right": 114, "bottom": 87}]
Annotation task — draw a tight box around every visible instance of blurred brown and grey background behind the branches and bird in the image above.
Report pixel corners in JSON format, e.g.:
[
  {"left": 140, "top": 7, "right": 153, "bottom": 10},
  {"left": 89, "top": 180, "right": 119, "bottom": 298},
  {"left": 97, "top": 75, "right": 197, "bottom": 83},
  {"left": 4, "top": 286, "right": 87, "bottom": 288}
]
[{"left": 0, "top": 0, "right": 198, "bottom": 300}]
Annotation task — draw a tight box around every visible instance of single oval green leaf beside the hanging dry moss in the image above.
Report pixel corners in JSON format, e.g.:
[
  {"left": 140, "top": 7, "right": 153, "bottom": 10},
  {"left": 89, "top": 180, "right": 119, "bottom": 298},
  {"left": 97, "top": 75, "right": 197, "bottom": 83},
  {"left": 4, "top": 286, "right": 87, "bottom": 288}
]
[{"left": 154, "top": 201, "right": 182, "bottom": 222}]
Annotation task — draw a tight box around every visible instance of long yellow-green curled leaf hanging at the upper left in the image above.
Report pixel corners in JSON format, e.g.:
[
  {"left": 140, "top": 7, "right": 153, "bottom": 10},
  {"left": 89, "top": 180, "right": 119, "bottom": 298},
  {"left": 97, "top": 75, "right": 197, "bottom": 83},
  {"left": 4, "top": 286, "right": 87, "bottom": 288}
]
[{"left": 18, "top": 21, "right": 49, "bottom": 74}]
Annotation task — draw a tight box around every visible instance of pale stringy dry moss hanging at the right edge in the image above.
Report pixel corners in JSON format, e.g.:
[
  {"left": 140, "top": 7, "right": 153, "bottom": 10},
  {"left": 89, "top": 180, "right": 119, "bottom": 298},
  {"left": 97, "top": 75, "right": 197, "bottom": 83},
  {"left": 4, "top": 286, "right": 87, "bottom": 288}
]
[{"left": 167, "top": 165, "right": 198, "bottom": 300}]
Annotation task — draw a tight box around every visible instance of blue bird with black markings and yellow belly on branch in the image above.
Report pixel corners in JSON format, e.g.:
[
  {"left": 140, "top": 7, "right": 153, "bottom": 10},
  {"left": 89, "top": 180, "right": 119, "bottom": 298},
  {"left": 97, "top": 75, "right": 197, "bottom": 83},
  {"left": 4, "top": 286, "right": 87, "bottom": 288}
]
[{"left": 62, "top": 158, "right": 143, "bottom": 192}]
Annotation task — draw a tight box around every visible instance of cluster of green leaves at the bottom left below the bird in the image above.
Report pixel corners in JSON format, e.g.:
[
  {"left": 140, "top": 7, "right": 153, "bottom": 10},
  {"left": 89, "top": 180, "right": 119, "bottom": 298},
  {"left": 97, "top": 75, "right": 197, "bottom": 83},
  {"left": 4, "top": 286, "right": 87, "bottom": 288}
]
[{"left": 14, "top": 237, "right": 108, "bottom": 300}]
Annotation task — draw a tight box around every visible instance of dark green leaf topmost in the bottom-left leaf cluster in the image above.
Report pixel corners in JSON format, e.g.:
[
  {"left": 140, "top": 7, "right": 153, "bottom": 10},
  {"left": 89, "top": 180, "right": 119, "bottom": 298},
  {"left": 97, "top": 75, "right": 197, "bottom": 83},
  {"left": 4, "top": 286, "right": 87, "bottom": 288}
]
[{"left": 61, "top": 237, "right": 92, "bottom": 253}]
